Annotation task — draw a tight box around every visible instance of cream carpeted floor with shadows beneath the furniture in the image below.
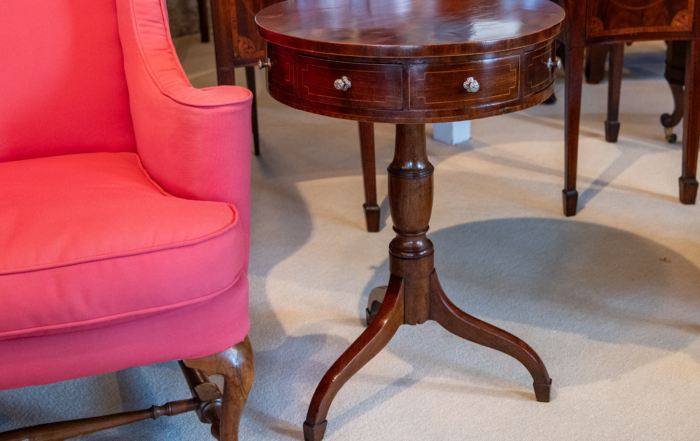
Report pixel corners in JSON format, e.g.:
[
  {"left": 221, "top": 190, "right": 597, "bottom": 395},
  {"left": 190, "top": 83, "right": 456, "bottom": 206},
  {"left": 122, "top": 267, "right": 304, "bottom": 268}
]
[{"left": 0, "top": 36, "right": 700, "bottom": 441}]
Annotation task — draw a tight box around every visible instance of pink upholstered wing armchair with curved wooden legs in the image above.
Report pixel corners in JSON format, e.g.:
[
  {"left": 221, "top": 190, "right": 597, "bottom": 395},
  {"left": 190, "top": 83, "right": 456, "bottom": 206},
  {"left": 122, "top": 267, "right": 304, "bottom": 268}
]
[{"left": 0, "top": 0, "right": 253, "bottom": 441}]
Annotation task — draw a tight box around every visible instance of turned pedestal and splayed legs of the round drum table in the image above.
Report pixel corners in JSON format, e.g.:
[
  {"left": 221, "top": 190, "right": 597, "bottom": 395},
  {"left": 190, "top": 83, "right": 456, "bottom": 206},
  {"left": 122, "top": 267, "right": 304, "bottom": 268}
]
[{"left": 304, "top": 124, "right": 552, "bottom": 441}]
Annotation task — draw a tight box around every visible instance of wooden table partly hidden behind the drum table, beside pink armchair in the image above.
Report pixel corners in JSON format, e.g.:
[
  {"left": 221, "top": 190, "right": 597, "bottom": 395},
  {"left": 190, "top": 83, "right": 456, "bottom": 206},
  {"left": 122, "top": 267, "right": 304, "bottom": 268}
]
[{"left": 208, "top": 0, "right": 381, "bottom": 233}]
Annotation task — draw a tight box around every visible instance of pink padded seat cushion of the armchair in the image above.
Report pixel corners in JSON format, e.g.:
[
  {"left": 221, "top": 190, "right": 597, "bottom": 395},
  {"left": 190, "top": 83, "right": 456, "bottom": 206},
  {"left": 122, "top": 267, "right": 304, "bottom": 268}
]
[{"left": 0, "top": 153, "right": 247, "bottom": 340}]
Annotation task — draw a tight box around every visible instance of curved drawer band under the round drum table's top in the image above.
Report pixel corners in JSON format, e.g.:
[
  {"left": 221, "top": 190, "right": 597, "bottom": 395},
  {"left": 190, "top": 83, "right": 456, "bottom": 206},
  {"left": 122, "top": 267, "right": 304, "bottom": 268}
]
[{"left": 266, "top": 41, "right": 554, "bottom": 124}]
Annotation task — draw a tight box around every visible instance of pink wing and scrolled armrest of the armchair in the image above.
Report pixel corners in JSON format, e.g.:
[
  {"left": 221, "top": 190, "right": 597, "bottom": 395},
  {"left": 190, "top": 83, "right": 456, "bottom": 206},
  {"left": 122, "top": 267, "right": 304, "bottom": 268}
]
[{"left": 117, "top": 0, "right": 252, "bottom": 237}]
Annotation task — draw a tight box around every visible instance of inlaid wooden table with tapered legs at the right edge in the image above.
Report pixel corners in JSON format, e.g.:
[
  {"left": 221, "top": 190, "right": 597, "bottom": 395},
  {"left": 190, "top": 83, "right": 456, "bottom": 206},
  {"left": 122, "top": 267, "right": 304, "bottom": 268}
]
[{"left": 562, "top": 0, "right": 700, "bottom": 216}]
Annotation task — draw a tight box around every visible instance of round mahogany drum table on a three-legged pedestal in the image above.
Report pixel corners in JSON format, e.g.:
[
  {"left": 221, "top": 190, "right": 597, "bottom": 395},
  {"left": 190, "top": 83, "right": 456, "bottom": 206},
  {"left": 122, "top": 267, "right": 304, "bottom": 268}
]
[{"left": 256, "top": 0, "right": 564, "bottom": 441}]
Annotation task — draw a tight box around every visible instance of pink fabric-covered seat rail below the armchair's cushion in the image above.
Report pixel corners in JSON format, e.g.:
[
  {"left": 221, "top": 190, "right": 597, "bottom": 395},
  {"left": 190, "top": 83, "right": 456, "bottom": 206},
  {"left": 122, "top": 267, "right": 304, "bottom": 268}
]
[{"left": 0, "top": 277, "right": 250, "bottom": 388}]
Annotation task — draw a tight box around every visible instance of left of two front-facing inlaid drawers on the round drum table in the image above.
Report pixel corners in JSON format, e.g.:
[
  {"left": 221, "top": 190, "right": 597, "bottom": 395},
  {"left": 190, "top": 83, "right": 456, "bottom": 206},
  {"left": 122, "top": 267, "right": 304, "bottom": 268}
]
[{"left": 297, "top": 55, "right": 403, "bottom": 110}]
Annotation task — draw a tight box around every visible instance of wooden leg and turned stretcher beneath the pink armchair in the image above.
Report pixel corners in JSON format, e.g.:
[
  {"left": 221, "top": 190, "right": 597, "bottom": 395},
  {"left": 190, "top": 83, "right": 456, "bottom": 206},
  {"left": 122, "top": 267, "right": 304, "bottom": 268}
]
[{"left": 0, "top": 337, "right": 254, "bottom": 441}]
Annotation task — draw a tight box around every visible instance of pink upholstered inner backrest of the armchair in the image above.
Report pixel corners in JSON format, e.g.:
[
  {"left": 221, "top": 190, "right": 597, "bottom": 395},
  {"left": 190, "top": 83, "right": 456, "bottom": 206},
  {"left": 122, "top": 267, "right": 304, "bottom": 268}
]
[{"left": 0, "top": 0, "right": 136, "bottom": 162}]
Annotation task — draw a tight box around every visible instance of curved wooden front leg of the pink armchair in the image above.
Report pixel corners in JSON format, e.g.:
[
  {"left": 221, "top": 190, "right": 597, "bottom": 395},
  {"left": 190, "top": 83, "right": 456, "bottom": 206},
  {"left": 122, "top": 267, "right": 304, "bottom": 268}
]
[{"left": 183, "top": 337, "right": 255, "bottom": 441}]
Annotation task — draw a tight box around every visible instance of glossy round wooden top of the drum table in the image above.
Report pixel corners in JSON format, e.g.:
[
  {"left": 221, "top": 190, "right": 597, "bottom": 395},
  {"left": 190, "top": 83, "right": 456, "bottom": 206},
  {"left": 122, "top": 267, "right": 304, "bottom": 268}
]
[{"left": 255, "top": 0, "right": 564, "bottom": 57}]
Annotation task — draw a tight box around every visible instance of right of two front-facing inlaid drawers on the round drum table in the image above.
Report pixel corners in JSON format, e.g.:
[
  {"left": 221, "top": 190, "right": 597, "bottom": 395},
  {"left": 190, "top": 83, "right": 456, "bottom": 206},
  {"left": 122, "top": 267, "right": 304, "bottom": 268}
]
[{"left": 409, "top": 55, "right": 520, "bottom": 110}]
